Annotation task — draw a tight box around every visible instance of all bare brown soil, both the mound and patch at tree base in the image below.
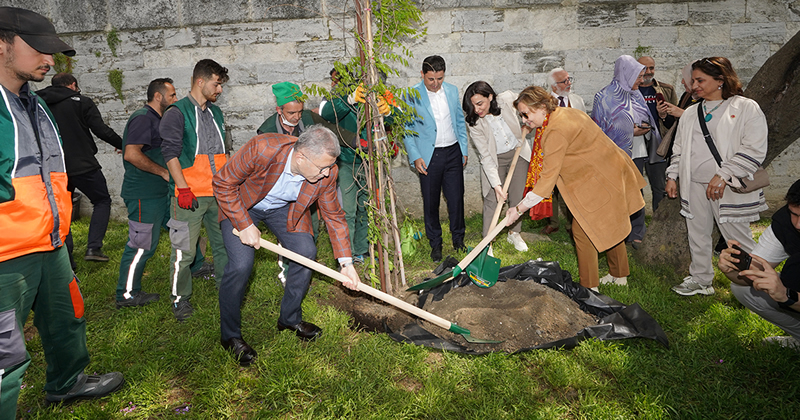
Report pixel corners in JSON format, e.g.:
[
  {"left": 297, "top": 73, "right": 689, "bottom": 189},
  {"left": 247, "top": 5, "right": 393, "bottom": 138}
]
[{"left": 323, "top": 280, "right": 598, "bottom": 352}]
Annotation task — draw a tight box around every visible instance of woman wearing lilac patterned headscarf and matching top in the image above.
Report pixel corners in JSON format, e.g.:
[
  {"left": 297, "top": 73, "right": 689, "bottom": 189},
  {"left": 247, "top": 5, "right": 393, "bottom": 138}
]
[{"left": 592, "top": 55, "right": 661, "bottom": 248}]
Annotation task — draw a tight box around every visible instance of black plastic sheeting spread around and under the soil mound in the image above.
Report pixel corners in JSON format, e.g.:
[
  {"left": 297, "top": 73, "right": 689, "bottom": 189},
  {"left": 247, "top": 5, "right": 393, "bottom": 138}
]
[{"left": 387, "top": 259, "right": 669, "bottom": 355}]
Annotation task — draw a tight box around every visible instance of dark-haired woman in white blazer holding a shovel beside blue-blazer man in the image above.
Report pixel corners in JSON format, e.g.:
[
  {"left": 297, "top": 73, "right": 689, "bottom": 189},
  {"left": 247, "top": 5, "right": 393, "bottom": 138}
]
[{"left": 462, "top": 81, "right": 531, "bottom": 252}]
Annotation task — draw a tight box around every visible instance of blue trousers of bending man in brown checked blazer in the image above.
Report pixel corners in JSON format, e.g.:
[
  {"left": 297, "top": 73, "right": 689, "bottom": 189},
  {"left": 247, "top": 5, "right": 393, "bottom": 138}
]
[{"left": 219, "top": 205, "right": 317, "bottom": 340}]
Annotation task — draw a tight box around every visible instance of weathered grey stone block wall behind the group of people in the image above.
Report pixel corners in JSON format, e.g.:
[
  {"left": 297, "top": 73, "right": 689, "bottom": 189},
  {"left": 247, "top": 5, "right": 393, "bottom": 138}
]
[{"left": 12, "top": 0, "right": 800, "bottom": 218}]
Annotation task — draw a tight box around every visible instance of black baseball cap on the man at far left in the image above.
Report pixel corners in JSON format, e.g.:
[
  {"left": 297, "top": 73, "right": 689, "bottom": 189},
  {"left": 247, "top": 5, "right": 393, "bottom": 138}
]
[{"left": 0, "top": 7, "right": 75, "bottom": 57}]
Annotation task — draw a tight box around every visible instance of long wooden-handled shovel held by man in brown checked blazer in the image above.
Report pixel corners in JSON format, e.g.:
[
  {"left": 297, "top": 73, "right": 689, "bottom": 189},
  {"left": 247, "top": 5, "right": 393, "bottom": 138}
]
[{"left": 233, "top": 229, "right": 502, "bottom": 344}]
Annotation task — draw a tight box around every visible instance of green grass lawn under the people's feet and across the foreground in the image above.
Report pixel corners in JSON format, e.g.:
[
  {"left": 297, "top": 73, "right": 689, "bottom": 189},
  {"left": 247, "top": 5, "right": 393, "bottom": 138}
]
[{"left": 19, "top": 215, "right": 800, "bottom": 419}]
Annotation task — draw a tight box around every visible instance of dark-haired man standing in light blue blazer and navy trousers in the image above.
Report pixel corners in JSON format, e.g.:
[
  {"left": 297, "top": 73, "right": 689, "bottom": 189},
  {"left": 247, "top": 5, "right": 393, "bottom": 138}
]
[{"left": 405, "top": 55, "right": 467, "bottom": 262}]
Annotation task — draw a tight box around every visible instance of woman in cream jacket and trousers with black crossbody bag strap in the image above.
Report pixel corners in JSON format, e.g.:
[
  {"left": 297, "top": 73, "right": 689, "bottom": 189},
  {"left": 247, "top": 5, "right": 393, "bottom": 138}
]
[{"left": 666, "top": 57, "right": 768, "bottom": 296}]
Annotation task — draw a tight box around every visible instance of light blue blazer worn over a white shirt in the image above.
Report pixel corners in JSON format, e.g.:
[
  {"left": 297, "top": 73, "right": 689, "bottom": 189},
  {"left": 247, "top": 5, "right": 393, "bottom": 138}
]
[{"left": 403, "top": 82, "right": 468, "bottom": 167}]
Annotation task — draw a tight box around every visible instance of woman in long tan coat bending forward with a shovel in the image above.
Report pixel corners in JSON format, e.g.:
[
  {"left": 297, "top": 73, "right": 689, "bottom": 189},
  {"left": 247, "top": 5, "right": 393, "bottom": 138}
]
[{"left": 506, "top": 86, "right": 645, "bottom": 290}]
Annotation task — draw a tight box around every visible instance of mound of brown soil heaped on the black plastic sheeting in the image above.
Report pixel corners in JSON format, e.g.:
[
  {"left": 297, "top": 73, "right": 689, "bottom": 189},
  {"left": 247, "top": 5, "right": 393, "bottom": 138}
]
[{"left": 420, "top": 280, "right": 598, "bottom": 353}]
